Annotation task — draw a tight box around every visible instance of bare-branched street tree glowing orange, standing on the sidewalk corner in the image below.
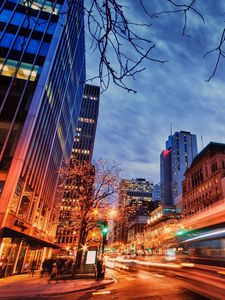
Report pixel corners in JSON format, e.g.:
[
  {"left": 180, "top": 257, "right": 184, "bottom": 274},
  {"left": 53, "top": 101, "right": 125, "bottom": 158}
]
[{"left": 58, "top": 157, "right": 120, "bottom": 267}]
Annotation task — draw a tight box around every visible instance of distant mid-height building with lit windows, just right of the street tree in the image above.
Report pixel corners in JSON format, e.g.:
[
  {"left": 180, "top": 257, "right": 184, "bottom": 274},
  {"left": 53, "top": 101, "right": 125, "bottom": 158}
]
[{"left": 114, "top": 178, "right": 155, "bottom": 242}]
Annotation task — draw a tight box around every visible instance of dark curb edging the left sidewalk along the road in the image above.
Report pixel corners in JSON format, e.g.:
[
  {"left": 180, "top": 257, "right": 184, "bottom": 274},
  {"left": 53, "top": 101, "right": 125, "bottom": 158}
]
[{"left": 0, "top": 278, "right": 115, "bottom": 300}]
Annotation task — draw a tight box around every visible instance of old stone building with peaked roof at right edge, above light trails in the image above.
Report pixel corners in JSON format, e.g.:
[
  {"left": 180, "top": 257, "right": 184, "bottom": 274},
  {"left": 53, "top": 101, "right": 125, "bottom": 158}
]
[{"left": 182, "top": 142, "right": 225, "bottom": 227}]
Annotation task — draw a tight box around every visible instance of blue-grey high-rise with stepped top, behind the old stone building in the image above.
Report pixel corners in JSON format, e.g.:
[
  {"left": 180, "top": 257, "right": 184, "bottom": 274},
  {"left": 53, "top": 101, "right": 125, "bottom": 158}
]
[{"left": 160, "top": 131, "right": 198, "bottom": 205}]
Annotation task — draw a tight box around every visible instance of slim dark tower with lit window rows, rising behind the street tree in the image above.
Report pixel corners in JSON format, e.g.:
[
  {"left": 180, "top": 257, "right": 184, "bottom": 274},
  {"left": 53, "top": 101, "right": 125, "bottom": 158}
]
[{"left": 56, "top": 84, "right": 100, "bottom": 255}]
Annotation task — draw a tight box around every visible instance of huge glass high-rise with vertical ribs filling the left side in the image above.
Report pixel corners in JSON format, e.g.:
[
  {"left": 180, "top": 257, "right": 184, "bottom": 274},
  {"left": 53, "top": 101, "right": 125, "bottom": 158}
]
[{"left": 0, "top": 0, "right": 85, "bottom": 275}]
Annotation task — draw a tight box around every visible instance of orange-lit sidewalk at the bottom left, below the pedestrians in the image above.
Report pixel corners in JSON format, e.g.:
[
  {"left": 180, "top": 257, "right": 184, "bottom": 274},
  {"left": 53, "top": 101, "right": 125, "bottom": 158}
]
[{"left": 0, "top": 272, "right": 114, "bottom": 299}]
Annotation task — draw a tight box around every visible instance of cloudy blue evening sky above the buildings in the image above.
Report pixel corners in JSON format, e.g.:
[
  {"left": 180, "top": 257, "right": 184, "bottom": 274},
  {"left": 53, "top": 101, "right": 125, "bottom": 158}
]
[{"left": 86, "top": 0, "right": 225, "bottom": 183}]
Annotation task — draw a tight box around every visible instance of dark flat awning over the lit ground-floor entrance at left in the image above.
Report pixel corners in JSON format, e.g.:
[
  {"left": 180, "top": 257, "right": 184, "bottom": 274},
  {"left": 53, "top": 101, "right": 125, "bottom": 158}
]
[{"left": 0, "top": 227, "right": 61, "bottom": 249}]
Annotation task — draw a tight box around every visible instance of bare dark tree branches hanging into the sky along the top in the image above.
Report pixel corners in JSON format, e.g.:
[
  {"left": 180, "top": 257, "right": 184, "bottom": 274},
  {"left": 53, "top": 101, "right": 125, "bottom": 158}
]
[{"left": 15, "top": 0, "right": 225, "bottom": 92}]
